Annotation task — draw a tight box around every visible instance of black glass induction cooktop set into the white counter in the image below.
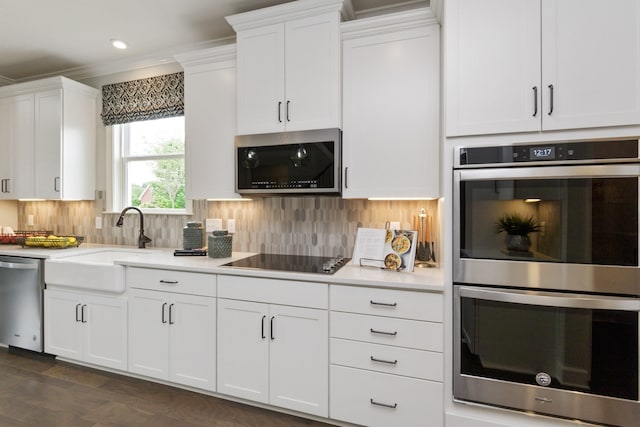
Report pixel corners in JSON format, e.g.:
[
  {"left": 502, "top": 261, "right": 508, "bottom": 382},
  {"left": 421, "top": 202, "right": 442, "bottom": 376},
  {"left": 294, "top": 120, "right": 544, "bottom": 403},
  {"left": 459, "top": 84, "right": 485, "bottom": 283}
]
[{"left": 223, "top": 254, "right": 349, "bottom": 274}]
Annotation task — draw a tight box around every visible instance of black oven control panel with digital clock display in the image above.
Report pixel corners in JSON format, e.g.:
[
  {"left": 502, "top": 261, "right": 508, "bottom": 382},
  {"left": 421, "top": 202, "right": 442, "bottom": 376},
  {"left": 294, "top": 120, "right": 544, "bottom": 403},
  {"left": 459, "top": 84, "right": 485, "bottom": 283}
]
[{"left": 456, "top": 139, "right": 638, "bottom": 167}]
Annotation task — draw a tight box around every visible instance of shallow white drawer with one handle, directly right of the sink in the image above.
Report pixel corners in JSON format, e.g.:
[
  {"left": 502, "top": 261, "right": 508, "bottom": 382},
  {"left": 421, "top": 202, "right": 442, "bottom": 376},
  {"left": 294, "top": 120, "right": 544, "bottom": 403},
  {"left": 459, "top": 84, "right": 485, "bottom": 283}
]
[{"left": 126, "top": 267, "right": 216, "bottom": 297}]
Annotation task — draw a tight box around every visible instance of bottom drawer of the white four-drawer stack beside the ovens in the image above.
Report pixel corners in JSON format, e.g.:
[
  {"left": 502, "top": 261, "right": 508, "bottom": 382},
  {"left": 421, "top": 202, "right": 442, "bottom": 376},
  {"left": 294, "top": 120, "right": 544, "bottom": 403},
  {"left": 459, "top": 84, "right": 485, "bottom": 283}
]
[{"left": 329, "top": 365, "right": 443, "bottom": 427}]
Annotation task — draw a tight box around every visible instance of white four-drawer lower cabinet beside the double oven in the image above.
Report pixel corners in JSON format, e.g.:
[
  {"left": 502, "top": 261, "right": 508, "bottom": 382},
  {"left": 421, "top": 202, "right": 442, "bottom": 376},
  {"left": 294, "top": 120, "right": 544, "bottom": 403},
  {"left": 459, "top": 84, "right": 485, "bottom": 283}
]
[{"left": 330, "top": 285, "right": 444, "bottom": 427}]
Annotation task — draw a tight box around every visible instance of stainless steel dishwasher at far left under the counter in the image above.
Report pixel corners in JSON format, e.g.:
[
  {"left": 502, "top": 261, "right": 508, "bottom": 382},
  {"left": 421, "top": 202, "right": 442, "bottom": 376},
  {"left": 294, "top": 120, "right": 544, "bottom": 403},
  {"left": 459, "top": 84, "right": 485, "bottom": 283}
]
[{"left": 0, "top": 256, "right": 44, "bottom": 352}]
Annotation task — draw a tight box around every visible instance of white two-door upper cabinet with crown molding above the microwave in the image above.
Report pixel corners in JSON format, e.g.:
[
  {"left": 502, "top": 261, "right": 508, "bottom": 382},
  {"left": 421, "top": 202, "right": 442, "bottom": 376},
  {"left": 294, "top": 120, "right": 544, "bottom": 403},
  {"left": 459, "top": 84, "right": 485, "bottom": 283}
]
[{"left": 227, "top": 0, "right": 342, "bottom": 135}]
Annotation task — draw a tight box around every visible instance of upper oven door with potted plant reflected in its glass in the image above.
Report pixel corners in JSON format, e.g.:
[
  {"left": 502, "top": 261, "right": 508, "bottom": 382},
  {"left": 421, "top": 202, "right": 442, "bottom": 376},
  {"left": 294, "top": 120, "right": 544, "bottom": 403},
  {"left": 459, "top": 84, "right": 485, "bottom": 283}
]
[{"left": 454, "top": 164, "right": 640, "bottom": 295}]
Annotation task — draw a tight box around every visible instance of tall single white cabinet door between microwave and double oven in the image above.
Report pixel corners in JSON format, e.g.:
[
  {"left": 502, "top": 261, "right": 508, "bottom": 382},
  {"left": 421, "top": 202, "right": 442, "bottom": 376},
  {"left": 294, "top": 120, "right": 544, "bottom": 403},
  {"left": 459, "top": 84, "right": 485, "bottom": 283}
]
[{"left": 343, "top": 25, "right": 440, "bottom": 198}]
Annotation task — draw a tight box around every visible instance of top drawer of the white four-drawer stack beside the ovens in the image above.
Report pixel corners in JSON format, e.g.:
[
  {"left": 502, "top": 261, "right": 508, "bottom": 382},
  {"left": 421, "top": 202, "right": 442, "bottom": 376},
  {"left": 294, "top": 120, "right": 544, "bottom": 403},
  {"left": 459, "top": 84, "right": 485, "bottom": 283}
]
[{"left": 330, "top": 285, "right": 443, "bottom": 322}]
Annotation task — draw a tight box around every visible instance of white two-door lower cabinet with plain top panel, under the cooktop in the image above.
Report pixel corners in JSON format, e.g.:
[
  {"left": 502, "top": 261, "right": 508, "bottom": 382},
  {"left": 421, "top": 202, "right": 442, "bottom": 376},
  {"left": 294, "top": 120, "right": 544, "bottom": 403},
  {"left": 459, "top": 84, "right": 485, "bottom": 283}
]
[{"left": 217, "top": 276, "right": 329, "bottom": 417}]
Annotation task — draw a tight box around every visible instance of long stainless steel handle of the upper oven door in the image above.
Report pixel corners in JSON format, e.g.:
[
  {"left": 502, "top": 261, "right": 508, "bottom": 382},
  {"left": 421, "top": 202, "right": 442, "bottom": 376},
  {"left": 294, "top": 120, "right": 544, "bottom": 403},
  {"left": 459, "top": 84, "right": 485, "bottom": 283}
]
[{"left": 455, "top": 163, "right": 640, "bottom": 181}]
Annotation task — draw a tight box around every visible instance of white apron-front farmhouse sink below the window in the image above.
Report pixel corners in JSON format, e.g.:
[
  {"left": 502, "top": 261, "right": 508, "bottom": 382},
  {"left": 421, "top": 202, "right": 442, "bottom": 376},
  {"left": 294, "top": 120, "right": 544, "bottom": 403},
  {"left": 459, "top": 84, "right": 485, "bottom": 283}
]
[{"left": 44, "top": 249, "right": 152, "bottom": 293}]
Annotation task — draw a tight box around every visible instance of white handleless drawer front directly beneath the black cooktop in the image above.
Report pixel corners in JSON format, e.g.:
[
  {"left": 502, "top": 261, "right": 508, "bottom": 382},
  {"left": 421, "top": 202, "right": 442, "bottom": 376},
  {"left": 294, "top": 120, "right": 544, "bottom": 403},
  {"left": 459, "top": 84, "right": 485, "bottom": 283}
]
[{"left": 218, "top": 275, "right": 329, "bottom": 310}]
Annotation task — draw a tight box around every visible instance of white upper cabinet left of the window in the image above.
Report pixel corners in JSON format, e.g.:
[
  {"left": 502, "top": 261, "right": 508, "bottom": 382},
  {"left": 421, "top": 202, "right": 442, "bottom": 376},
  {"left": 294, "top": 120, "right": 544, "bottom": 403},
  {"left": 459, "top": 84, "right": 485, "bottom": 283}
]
[{"left": 0, "top": 77, "right": 98, "bottom": 200}]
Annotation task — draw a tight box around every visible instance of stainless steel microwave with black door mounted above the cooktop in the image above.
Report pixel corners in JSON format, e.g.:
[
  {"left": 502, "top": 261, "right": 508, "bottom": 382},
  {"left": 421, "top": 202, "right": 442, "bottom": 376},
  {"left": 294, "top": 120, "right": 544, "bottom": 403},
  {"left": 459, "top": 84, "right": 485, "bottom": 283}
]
[{"left": 235, "top": 128, "right": 342, "bottom": 196}]
